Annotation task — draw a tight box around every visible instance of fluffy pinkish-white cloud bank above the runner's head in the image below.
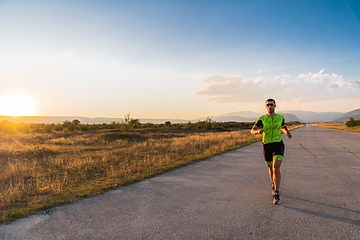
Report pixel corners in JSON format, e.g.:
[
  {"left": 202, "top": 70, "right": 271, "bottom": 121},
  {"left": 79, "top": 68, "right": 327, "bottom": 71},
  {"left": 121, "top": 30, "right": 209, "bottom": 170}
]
[{"left": 195, "top": 69, "right": 360, "bottom": 103}]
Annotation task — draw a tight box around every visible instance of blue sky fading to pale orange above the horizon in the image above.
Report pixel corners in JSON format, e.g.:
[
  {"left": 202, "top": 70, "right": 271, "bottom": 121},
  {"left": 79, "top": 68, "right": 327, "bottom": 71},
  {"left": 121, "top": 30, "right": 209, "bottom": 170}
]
[{"left": 0, "top": 0, "right": 360, "bottom": 119}]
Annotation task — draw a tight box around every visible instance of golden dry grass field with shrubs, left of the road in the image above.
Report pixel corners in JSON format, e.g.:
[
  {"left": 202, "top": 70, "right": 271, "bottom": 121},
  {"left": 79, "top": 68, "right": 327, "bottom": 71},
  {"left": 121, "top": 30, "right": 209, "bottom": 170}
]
[{"left": 0, "top": 115, "right": 301, "bottom": 223}]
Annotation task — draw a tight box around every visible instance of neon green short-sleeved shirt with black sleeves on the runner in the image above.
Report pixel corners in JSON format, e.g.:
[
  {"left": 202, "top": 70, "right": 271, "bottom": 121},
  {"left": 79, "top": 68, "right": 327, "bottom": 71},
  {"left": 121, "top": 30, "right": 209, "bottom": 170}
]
[{"left": 255, "top": 114, "right": 285, "bottom": 144}]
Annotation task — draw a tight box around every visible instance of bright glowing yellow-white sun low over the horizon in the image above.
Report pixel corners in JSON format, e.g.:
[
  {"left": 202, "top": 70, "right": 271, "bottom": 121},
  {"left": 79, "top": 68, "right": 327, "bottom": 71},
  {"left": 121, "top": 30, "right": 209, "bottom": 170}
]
[{"left": 0, "top": 92, "right": 36, "bottom": 117}]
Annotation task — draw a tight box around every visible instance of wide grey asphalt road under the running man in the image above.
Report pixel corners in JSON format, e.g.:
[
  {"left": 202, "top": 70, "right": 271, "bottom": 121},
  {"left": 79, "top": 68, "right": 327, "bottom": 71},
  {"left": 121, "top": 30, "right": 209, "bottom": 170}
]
[{"left": 0, "top": 126, "right": 360, "bottom": 239}]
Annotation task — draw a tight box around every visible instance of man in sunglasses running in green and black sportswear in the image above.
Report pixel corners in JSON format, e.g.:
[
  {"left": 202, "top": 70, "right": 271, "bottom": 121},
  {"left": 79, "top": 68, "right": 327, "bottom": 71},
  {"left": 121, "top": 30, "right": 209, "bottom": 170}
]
[{"left": 251, "top": 98, "right": 292, "bottom": 204}]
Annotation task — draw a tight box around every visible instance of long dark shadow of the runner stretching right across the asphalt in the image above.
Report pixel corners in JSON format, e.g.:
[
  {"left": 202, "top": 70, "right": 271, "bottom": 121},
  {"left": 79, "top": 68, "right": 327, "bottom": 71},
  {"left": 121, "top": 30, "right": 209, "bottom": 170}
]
[{"left": 281, "top": 195, "right": 360, "bottom": 226}]
